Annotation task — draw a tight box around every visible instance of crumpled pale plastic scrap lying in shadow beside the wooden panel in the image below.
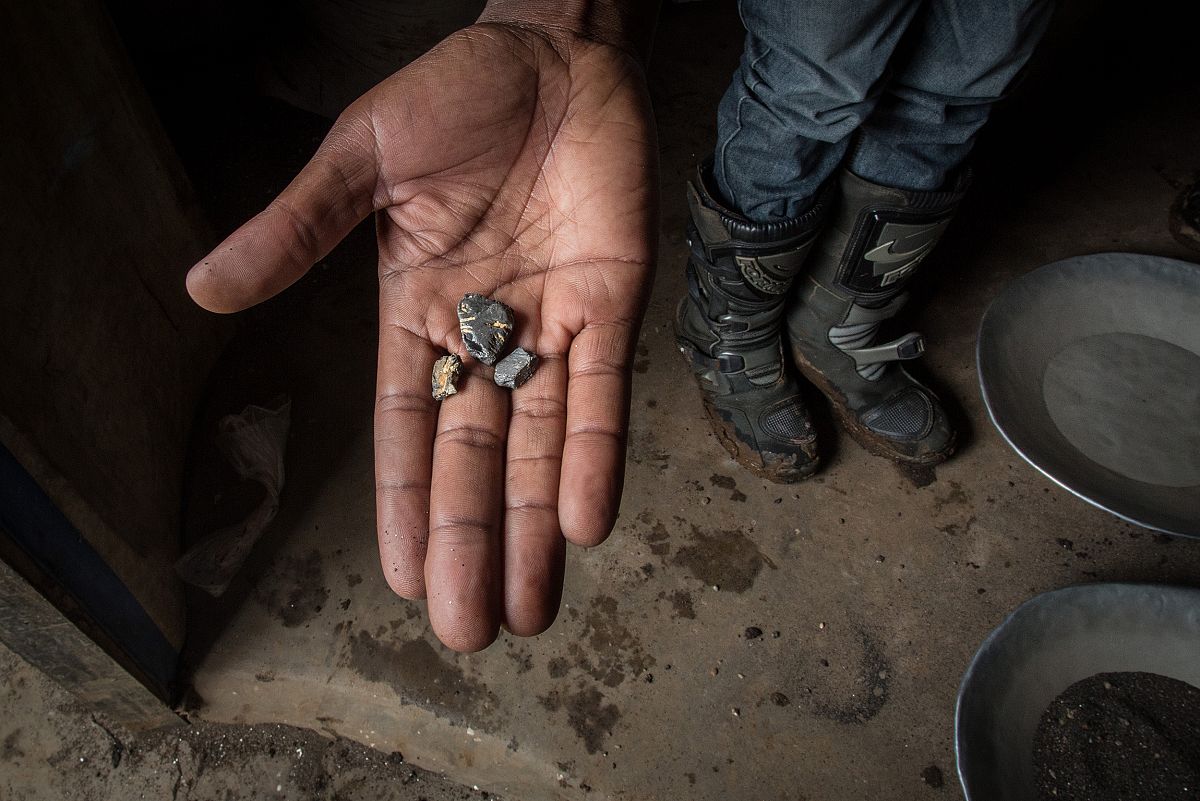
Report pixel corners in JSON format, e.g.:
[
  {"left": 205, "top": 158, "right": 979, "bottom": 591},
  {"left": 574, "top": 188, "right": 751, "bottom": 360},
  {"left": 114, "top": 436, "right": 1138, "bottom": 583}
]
[{"left": 175, "top": 397, "right": 292, "bottom": 597}]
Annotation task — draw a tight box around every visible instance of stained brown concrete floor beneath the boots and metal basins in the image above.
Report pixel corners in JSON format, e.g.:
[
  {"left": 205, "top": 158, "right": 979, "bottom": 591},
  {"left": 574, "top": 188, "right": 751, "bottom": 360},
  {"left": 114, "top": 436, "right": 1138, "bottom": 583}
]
[{"left": 157, "top": 4, "right": 1200, "bottom": 801}]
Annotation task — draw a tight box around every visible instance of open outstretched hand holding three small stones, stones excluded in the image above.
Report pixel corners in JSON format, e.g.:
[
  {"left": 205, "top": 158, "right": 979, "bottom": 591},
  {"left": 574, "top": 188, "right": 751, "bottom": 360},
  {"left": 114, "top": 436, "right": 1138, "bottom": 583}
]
[{"left": 188, "top": 25, "right": 656, "bottom": 650}]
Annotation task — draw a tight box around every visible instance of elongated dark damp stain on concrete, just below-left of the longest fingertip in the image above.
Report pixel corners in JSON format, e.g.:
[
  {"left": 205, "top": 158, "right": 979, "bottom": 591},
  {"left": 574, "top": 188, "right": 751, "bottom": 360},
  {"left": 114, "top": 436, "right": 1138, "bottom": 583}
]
[{"left": 344, "top": 631, "right": 499, "bottom": 725}]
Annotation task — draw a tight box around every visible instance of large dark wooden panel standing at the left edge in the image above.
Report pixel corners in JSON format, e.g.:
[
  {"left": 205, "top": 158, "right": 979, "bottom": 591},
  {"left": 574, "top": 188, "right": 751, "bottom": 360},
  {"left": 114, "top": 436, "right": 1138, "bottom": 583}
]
[{"left": 0, "top": 0, "right": 224, "bottom": 650}]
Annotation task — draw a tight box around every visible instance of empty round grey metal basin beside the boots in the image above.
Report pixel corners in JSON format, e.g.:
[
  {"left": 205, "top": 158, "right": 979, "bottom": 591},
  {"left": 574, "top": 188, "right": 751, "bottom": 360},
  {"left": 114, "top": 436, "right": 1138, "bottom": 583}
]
[{"left": 976, "top": 253, "right": 1200, "bottom": 537}]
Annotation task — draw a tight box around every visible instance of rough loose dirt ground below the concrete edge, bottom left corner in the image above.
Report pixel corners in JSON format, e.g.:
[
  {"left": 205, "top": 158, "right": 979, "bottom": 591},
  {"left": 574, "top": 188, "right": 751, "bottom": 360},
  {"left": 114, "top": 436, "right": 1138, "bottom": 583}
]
[{"left": 0, "top": 646, "right": 499, "bottom": 801}]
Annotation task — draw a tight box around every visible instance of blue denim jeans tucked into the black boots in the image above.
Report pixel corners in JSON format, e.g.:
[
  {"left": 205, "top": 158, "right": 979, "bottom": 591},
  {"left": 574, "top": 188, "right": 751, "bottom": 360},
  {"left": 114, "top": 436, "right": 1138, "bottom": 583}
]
[{"left": 713, "top": 0, "right": 1052, "bottom": 222}]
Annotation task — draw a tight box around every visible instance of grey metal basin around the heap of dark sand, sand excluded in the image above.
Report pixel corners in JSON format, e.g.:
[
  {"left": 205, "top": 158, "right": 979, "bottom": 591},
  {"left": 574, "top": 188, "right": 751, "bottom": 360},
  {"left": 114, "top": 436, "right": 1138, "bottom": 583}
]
[{"left": 954, "top": 584, "right": 1200, "bottom": 801}]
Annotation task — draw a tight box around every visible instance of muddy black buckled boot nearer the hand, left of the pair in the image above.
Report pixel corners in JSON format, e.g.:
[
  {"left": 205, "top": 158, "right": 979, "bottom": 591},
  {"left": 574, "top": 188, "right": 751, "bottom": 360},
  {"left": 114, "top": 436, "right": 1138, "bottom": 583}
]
[{"left": 674, "top": 159, "right": 824, "bottom": 483}]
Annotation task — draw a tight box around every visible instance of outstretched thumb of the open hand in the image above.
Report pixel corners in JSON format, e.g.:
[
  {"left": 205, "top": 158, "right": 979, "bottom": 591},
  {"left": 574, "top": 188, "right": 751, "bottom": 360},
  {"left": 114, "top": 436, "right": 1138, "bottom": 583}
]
[{"left": 187, "top": 119, "right": 378, "bottom": 313}]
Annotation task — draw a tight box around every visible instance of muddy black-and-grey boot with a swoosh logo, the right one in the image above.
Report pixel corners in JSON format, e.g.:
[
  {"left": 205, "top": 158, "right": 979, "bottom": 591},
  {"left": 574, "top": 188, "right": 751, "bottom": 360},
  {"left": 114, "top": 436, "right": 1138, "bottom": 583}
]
[{"left": 787, "top": 170, "right": 967, "bottom": 466}]
